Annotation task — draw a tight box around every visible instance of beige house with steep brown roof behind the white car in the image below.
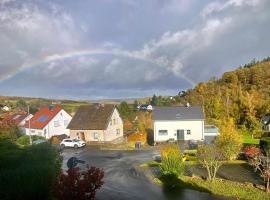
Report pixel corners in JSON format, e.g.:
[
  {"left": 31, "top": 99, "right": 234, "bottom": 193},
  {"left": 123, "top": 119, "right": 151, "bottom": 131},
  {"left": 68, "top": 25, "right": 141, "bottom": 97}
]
[{"left": 68, "top": 104, "right": 123, "bottom": 142}]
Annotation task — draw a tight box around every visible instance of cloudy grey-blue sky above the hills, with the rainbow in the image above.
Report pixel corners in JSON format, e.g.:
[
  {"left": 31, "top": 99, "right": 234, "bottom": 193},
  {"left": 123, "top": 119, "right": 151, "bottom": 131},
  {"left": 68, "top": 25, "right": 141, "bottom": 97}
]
[{"left": 0, "top": 0, "right": 270, "bottom": 100}]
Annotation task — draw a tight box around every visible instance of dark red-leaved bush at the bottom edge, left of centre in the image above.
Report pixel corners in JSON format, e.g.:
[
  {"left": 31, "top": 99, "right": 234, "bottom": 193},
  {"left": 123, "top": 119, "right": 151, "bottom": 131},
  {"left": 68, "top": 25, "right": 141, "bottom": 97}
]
[{"left": 55, "top": 166, "right": 104, "bottom": 200}]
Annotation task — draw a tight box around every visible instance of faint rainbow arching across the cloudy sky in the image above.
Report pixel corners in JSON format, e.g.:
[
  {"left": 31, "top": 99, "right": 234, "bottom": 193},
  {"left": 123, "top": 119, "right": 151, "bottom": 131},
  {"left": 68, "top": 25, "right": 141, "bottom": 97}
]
[{"left": 0, "top": 49, "right": 196, "bottom": 86}]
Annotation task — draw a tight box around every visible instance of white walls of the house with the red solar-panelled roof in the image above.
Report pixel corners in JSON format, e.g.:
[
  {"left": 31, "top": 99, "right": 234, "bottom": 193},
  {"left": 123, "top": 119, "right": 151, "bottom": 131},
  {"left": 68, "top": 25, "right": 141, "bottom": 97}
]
[{"left": 26, "top": 109, "right": 72, "bottom": 139}]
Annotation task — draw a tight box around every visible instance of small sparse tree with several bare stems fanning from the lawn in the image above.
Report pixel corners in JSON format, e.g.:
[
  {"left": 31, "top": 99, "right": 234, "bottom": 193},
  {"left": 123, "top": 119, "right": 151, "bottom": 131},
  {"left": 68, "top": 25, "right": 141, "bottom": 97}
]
[{"left": 197, "top": 144, "right": 223, "bottom": 180}]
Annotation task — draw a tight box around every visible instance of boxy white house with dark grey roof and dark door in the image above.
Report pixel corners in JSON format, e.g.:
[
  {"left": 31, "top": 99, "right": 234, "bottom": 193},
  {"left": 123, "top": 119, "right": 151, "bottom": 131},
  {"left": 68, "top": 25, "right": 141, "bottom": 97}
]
[{"left": 153, "top": 106, "right": 204, "bottom": 142}]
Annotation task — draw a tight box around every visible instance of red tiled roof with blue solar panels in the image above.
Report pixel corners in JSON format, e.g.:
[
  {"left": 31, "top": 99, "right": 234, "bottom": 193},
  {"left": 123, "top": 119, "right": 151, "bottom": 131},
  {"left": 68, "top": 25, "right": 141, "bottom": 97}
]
[{"left": 25, "top": 105, "right": 62, "bottom": 129}]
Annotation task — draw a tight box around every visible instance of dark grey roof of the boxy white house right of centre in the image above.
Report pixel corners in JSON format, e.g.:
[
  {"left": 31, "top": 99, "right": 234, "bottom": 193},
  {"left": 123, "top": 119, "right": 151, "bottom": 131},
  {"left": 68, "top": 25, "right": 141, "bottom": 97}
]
[{"left": 153, "top": 106, "right": 204, "bottom": 121}]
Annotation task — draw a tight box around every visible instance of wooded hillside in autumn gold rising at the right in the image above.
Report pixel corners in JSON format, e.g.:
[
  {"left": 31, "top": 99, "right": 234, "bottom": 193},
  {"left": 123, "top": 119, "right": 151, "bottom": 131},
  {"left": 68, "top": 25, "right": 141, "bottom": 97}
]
[{"left": 176, "top": 57, "right": 270, "bottom": 134}]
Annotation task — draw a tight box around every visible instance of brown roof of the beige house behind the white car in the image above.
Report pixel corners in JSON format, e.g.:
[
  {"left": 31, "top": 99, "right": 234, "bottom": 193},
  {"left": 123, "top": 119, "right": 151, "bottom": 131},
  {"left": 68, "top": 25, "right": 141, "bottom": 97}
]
[{"left": 67, "top": 104, "right": 116, "bottom": 130}]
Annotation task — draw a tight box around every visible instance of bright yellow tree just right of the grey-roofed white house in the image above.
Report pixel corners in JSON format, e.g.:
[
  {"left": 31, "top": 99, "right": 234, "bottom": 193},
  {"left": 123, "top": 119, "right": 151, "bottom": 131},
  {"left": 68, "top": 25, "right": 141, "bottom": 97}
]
[{"left": 215, "top": 119, "right": 242, "bottom": 160}]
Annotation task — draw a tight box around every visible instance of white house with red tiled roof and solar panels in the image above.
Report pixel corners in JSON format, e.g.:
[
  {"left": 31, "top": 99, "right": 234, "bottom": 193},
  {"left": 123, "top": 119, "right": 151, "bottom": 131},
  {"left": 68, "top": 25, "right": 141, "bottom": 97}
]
[{"left": 25, "top": 105, "right": 72, "bottom": 139}]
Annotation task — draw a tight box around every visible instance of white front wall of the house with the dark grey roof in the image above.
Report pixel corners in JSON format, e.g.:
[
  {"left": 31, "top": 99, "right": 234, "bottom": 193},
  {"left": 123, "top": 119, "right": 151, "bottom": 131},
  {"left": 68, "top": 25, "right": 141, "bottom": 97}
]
[{"left": 154, "top": 120, "right": 204, "bottom": 142}]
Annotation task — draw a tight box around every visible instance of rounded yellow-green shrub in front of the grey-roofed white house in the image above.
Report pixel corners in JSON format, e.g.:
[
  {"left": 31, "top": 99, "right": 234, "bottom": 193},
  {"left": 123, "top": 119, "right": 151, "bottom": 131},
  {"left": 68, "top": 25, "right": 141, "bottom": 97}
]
[{"left": 160, "top": 144, "right": 185, "bottom": 176}]
